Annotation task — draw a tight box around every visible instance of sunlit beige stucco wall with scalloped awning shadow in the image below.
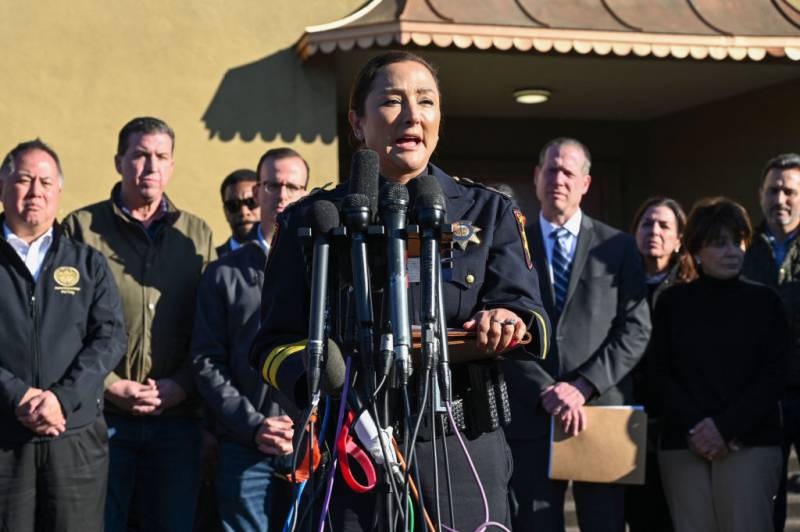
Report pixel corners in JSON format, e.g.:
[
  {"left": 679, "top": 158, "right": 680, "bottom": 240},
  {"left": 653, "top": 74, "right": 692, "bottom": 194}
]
[{"left": 0, "top": 0, "right": 363, "bottom": 242}]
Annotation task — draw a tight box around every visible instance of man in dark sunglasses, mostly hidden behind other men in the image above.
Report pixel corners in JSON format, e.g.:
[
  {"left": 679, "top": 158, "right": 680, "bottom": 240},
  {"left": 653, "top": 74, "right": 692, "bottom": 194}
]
[{"left": 217, "top": 169, "right": 261, "bottom": 257}]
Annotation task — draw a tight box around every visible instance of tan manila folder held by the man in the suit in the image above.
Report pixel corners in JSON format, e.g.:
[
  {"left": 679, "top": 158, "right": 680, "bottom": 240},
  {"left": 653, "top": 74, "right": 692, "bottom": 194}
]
[{"left": 549, "top": 406, "right": 647, "bottom": 484}]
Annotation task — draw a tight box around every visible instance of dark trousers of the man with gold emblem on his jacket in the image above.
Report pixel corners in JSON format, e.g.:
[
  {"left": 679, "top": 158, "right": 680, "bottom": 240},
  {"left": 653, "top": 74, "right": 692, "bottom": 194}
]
[{"left": 0, "top": 418, "right": 108, "bottom": 532}]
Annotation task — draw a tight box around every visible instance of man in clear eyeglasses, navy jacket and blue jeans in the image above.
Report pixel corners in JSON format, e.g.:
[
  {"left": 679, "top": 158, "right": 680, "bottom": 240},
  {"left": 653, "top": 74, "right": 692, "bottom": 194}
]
[{"left": 192, "top": 148, "right": 308, "bottom": 531}]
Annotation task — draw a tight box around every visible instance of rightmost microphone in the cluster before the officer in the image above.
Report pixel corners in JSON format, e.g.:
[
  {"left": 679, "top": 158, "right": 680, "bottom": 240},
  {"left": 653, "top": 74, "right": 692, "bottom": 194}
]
[{"left": 414, "top": 175, "right": 450, "bottom": 399}]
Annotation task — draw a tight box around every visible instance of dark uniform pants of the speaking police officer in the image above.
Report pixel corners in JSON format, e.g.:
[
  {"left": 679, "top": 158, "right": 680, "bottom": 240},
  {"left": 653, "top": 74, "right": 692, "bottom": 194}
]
[{"left": 330, "top": 430, "right": 513, "bottom": 532}]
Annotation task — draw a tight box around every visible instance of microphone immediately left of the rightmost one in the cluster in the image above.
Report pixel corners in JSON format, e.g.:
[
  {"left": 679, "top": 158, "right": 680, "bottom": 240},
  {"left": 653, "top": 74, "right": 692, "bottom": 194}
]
[{"left": 380, "top": 183, "right": 411, "bottom": 386}]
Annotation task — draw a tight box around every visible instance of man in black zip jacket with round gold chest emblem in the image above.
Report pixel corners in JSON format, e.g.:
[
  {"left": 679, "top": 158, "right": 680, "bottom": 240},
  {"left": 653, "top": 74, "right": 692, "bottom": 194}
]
[{"left": 0, "top": 140, "right": 126, "bottom": 532}]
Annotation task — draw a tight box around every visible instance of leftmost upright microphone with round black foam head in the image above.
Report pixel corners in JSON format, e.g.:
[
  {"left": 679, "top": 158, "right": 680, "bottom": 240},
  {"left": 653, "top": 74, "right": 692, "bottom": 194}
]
[{"left": 306, "top": 200, "right": 339, "bottom": 404}]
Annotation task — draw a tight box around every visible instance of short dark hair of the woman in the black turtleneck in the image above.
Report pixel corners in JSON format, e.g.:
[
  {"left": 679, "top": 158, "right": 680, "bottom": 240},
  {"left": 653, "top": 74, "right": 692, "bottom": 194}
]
[{"left": 683, "top": 197, "right": 753, "bottom": 276}]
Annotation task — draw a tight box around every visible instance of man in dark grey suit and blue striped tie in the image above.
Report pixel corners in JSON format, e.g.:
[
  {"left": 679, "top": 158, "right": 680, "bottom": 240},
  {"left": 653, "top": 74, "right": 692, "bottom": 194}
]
[{"left": 506, "top": 138, "right": 650, "bottom": 532}]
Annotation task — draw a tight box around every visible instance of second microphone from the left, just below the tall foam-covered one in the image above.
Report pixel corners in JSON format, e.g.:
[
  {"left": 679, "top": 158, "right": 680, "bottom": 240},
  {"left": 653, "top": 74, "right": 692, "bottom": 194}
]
[{"left": 342, "top": 194, "right": 375, "bottom": 396}]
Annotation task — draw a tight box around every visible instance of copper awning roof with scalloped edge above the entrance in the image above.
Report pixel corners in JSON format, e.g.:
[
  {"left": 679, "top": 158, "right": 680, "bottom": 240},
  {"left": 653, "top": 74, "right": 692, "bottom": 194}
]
[{"left": 297, "top": 0, "right": 800, "bottom": 61}]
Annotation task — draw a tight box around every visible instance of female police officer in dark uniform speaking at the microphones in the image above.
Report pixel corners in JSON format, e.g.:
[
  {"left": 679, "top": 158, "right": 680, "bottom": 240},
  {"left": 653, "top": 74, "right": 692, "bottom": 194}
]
[{"left": 252, "top": 52, "right": 548, "bottom": 531}]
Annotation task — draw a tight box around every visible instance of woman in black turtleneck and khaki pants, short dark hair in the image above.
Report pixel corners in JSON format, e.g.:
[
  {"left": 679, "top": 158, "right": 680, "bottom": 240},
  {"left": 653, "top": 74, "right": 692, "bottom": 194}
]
[{"left": 650, "top": 198, "right": 790, "bottom": 532}]
